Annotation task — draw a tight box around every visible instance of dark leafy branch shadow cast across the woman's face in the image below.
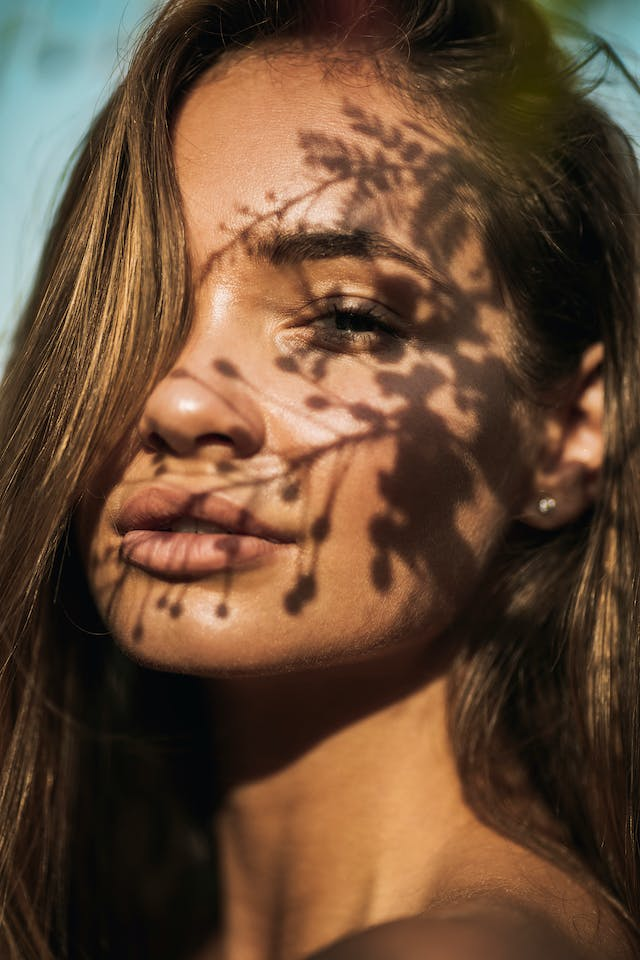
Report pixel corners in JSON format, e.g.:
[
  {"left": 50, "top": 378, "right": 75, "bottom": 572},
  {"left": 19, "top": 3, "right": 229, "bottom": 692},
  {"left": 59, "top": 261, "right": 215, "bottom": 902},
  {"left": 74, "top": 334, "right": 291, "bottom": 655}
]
[{"left": 92, "top": 102, "right": 524, "bottom": 643}]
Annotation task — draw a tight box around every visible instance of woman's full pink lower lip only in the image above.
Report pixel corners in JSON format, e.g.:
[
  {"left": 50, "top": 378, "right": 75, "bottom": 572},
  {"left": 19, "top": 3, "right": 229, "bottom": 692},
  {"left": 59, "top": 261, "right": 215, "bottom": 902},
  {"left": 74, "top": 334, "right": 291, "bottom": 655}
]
[{"left": 120, "top": 530, "right": 291, "bottom": 578}]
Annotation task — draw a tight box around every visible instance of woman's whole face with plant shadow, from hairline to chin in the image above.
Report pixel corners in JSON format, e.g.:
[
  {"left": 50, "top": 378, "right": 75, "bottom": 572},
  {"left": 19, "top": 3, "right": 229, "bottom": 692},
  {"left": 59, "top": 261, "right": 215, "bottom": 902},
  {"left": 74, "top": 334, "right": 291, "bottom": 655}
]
[{"left": 79, "top": 55, "right": 536, "bottom": 674}]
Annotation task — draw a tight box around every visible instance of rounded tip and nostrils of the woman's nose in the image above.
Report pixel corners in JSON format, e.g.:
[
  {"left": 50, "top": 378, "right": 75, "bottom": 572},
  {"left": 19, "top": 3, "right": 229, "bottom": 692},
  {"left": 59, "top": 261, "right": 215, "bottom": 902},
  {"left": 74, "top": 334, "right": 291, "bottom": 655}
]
[{"left": 138, "top": 363, "right": 265, "bottom": 458}]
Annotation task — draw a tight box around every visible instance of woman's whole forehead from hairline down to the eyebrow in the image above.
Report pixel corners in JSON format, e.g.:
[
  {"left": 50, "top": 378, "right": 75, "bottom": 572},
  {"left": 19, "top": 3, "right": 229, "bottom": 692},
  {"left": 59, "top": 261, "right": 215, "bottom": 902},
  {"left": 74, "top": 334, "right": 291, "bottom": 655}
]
[{"left": 174, "top": 53, "right": 478, "bottom": 266}]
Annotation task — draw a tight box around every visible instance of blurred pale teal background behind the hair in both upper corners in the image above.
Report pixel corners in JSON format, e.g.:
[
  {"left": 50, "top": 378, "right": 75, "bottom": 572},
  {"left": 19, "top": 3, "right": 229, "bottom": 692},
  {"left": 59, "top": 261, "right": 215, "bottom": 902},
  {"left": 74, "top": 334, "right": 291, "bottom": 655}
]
[{"left": 0, "top": 0, "right": 640, "bottom": 366}]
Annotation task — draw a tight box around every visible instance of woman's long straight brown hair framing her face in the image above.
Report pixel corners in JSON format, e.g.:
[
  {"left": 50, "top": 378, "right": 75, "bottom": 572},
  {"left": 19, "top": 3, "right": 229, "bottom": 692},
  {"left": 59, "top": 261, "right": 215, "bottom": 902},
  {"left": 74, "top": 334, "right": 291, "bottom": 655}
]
[{"left": 0, "top": 0, "right": 640, "bottom": 960}]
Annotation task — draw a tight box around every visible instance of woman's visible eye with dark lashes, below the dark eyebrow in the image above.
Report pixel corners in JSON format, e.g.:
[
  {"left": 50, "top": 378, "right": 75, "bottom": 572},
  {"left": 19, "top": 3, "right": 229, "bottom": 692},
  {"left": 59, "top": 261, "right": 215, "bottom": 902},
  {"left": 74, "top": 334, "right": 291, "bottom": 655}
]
[{"left": 309, "top": 303, "right": 400, "bottom": 353}]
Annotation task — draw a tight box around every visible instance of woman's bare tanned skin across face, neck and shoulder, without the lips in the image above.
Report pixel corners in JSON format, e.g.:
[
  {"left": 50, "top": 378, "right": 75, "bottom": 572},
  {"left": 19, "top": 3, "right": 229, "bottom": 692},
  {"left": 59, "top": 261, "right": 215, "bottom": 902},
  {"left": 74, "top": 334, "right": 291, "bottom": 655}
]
[{"left": 78, "top": 48, "right": 613, "bottom": 960}]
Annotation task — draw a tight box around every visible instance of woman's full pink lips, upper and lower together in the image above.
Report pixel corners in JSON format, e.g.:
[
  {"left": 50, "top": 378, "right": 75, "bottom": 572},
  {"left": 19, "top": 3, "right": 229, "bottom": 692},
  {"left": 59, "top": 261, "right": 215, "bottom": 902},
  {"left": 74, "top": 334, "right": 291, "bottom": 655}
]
[{"left": 115, "top": 486, "right": 296, "bottom": 579}]
